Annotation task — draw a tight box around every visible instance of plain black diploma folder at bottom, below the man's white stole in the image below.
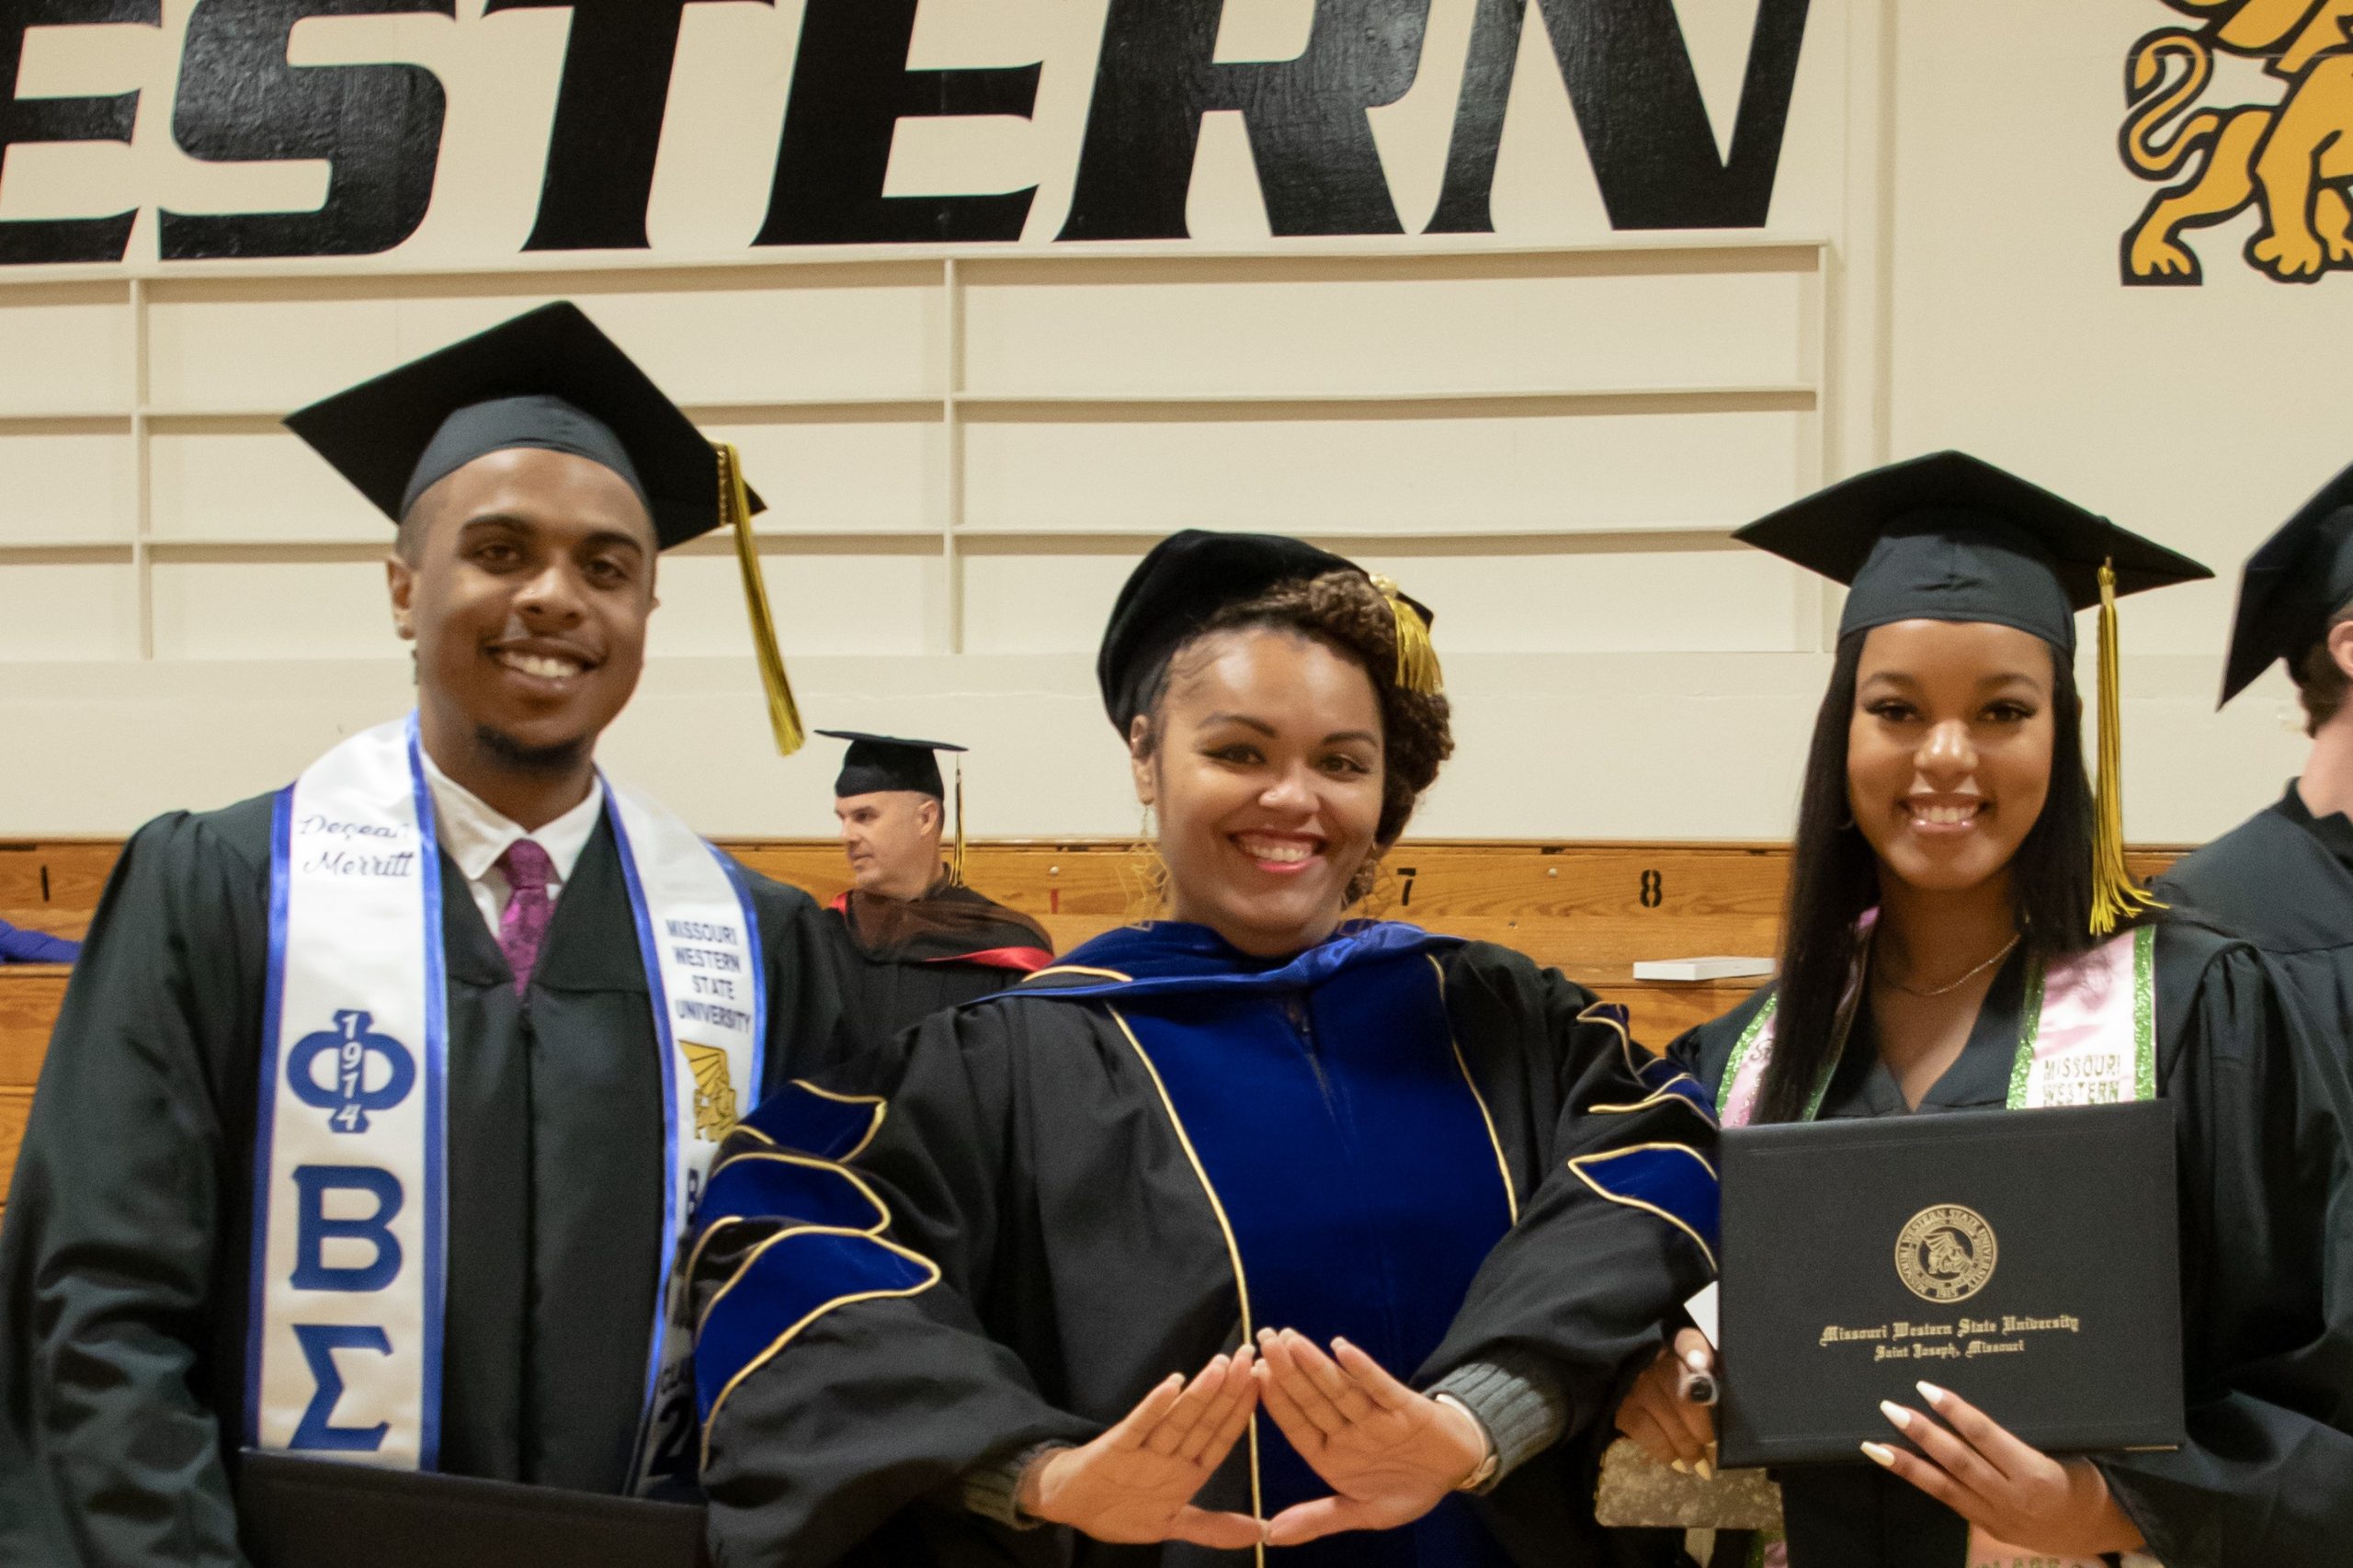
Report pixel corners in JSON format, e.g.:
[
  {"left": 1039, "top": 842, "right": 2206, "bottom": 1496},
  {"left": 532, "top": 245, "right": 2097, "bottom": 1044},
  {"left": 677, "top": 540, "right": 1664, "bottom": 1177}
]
[{"left": 238, "top": 1450, "right": 706, "bottom": 1568}]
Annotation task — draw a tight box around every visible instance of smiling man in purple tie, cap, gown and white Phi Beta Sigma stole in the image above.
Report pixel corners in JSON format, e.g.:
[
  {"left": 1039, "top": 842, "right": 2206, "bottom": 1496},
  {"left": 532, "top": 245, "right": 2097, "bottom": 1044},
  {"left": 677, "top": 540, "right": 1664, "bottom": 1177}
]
[{"left": 0, "top": 303, "right": 854, "bottom": 1568}]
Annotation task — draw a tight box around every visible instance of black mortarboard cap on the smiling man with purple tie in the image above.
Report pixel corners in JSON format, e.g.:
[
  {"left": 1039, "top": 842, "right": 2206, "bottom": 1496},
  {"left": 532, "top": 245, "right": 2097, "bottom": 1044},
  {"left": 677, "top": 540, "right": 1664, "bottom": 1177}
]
[{"left": 287, "top": 299, "right": 762, "bottom": 549}]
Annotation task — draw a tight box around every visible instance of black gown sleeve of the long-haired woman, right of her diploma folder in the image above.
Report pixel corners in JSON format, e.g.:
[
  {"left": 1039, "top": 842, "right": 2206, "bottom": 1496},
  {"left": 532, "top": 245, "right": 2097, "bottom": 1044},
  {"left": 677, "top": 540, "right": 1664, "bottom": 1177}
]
[{"left": 2101, "top": 947, "right": 2353, "bottom": 1568}]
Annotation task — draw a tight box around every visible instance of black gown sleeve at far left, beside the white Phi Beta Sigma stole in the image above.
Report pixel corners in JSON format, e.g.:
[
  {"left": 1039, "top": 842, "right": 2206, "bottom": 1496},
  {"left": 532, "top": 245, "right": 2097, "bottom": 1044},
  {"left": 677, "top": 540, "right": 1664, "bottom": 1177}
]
[{"left": 0, "top": 817, "right": 268, "bottom": 1568}]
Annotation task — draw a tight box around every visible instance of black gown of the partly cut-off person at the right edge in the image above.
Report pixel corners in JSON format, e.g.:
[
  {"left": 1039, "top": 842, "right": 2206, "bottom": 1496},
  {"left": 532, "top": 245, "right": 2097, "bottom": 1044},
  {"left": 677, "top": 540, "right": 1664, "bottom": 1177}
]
[{"left": 2158, "top": 784, "right": 2353, "bottom": 1096}]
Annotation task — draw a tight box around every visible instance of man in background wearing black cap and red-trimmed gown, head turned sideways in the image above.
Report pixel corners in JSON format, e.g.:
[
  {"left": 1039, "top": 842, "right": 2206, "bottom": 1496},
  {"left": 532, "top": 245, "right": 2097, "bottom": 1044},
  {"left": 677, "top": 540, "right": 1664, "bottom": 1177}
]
[{"left": 819, "top": 730, "right": 1054, "bottom": 1043}]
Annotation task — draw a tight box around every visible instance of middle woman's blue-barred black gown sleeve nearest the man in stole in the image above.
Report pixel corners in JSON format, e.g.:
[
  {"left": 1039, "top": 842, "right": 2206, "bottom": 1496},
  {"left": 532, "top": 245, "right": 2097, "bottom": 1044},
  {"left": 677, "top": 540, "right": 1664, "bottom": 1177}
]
[{"left": 692, "top": 1006, "right": 1097, "bottom": 1568}]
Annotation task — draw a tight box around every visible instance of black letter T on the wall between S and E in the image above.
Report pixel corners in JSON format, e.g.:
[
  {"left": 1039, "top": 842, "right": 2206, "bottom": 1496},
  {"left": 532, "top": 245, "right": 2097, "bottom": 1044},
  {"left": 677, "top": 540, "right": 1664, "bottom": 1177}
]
[{"left": 483, "top": 0, "right": 774, "bottom": 250}]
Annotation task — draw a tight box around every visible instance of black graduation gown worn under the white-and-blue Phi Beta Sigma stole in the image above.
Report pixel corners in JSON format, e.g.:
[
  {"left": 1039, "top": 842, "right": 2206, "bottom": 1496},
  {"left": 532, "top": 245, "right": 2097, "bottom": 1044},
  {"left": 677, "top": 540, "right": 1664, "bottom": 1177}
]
[{"left": 0, "top": 796, "right": 854, "bottom": 1568}]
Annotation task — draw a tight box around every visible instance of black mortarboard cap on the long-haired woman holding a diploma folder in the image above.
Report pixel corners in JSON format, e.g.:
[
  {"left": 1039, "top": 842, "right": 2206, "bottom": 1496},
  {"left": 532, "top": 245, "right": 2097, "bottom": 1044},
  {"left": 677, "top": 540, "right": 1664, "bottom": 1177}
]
[{"left": 1734, "top": 452, "right": 2214, "bottom": 654}]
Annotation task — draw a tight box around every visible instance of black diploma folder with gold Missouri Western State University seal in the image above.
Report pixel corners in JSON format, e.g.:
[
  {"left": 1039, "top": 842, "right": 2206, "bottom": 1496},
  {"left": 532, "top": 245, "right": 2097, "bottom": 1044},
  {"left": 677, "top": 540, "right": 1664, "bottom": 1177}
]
[{"left": 1718, "top": 1099, "right": 2184, "bottom": 1467}]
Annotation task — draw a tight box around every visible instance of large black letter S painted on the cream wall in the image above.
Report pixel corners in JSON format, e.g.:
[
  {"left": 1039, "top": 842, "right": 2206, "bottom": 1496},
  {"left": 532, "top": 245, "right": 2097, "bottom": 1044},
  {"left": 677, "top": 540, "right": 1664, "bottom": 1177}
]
[{"left": 158, "top": 0, "right": 457, "bottom": 261}]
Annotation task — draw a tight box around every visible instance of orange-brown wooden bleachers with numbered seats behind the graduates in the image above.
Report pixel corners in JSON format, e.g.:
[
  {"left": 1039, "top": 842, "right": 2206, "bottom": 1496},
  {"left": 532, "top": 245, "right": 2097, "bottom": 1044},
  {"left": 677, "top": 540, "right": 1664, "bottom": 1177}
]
[{"left": 0, "top": 838, "right": 2181, "bottom": 1214}]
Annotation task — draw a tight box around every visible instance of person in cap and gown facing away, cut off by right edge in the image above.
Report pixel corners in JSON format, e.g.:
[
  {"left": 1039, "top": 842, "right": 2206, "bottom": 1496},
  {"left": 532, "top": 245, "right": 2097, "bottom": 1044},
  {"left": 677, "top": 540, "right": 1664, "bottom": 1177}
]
[{"left": 2160, "top": 469, "right": 2353, "bottom": 1083}]
